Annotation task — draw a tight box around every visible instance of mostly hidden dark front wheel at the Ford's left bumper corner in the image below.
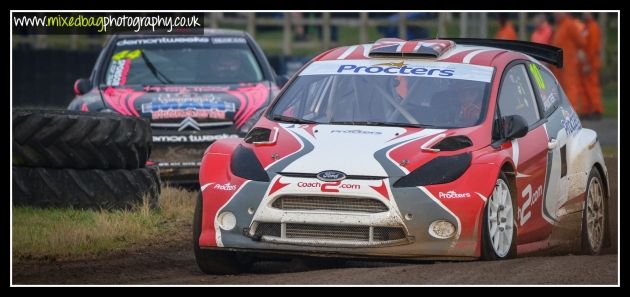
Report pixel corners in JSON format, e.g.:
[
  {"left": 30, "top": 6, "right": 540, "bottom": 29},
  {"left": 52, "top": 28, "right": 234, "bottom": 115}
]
[{"left": 192, "top": 193, "right": 249, "bottom": 275}]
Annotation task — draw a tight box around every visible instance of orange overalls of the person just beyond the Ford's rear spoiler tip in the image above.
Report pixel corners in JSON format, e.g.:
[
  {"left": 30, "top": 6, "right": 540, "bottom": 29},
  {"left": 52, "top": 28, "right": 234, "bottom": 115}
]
[{"left": 551, "top": 16, "right": 586, "bottom": 115}]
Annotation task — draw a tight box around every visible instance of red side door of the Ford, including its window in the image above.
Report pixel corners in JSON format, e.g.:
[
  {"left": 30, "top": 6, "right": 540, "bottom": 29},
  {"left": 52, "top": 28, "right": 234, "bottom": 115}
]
[{"left": 498, "top": 62, "right": 551, "bottom": 244}]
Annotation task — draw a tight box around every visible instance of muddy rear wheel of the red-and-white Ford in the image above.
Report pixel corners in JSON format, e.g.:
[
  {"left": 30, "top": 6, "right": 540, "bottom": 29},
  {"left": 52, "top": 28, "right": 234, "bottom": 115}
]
[{"left": 581, "top": 168, "right": 608, "bottom": 255}]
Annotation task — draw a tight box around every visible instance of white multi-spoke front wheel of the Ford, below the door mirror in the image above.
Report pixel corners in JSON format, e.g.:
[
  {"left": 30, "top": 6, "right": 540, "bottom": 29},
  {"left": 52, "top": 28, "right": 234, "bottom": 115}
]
[{"left": 481, "top": 172, "right": 517, "bottom": 260}]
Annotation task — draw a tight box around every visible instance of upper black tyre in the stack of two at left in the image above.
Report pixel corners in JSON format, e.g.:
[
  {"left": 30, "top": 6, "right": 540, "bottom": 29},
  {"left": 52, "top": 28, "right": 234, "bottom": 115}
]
[{"left": 13, "top": 109, "right": 152, "bottom": 169}]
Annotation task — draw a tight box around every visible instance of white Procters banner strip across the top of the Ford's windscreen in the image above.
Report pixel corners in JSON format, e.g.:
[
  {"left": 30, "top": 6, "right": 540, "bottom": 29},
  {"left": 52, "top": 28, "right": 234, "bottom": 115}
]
[{"left": 299, "top": 59, "right": 494, "bottom": 82}]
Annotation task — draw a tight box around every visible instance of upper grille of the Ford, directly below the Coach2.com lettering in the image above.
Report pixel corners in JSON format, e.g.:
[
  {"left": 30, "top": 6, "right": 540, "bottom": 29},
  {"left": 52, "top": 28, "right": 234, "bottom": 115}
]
[{"left": 271, "top": 196, "right": 387, "bottom": 213}]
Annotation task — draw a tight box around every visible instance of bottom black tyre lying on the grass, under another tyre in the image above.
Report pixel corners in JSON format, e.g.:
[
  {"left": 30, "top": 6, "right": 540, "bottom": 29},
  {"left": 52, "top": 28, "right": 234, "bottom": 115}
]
[{"left": 13, "top": 166, "right": 160, "bottom": 209}]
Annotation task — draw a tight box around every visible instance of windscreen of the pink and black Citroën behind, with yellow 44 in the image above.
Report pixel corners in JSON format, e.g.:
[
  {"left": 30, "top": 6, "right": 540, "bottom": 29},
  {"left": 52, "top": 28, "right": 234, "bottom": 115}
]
[{"left": 104, "top": 36, "right": 263, "bottom": 86}]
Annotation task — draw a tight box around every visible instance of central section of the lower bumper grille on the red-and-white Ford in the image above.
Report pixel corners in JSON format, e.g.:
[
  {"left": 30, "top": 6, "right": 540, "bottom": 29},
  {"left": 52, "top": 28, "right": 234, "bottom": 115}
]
[{"left": 287, "top": 224, "right": 370, "bottom": 241}]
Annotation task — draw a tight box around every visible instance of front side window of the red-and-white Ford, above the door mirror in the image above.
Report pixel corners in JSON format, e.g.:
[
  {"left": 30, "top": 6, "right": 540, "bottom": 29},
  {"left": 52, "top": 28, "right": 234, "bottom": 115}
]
[{"left": 499, "top": 64, "right": 540, "bottom": 126}]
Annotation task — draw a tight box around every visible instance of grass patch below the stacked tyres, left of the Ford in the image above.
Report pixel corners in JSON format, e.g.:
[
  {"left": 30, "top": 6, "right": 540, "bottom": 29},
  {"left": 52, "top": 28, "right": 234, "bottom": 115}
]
[{"left": 13, "top": 188, "right": 197, "bottom": 262}]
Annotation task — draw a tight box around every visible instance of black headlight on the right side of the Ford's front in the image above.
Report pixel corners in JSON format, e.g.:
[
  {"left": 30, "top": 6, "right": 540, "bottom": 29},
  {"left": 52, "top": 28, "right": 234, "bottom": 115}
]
[{"left": 394, "top": 153, "right": 472, "bottom": 188}]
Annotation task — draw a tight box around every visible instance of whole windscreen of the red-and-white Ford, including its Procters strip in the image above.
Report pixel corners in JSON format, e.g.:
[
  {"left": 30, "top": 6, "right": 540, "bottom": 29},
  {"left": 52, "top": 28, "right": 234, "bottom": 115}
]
[{"left": 270, "top": 60, "right": 493, "bottom": 128}]
